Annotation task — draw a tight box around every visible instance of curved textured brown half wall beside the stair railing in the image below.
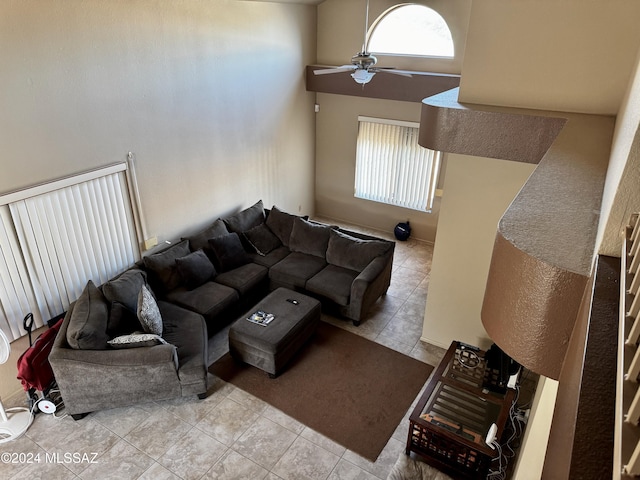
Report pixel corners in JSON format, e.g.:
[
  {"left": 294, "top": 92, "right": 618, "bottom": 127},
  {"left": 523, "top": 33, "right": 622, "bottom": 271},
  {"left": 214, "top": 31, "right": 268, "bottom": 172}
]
[{"left": 482, "top": 114, "right": 614, "bottom": 379}]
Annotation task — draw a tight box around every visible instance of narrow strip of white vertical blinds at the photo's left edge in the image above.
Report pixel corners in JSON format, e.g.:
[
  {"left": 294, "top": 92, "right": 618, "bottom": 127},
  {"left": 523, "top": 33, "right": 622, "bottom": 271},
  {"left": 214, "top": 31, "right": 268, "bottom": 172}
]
[{"left": 0, "top": 205, "right": 43, "bottom": 341}]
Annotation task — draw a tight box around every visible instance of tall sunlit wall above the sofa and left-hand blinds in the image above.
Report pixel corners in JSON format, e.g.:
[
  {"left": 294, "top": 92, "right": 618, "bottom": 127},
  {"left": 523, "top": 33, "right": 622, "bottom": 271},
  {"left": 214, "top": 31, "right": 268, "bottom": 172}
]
[{"left": 0, "top": 0, "right": 316, "bottom": 248}]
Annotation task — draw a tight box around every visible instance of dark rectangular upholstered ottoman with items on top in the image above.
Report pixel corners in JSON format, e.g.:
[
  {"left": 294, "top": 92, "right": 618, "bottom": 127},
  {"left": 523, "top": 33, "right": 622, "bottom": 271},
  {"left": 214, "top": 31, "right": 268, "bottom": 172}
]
[{"left": 229, "top": 288, "right": 320, "bottom": 377}]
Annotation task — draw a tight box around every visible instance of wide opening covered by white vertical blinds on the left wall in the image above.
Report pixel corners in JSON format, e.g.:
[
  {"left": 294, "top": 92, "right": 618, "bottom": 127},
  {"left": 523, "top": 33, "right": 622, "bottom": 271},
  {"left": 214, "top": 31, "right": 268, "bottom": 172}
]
[{"left": 0, "top": 164, "right": 140, "bottom": 339}]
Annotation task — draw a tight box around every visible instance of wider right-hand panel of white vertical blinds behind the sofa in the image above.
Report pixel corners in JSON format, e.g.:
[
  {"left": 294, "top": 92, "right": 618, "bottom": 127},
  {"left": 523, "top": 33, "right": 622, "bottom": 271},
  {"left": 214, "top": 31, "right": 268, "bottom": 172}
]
[{"left": 9, "top": 169, "right": 137, "bottom": 319}]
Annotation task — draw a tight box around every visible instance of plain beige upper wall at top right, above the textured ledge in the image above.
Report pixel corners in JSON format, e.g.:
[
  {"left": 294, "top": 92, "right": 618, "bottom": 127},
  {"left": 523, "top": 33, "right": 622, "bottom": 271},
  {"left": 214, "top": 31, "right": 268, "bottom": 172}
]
[{"left": 460, "top": 0, "right": 640, "bottom": 115}]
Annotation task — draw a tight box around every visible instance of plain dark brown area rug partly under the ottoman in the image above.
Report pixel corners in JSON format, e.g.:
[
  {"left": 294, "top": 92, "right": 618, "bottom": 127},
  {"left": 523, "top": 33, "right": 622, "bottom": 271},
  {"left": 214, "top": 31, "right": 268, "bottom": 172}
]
[{"left": 209, "top": 322, "right": 433, "bottom": 461}]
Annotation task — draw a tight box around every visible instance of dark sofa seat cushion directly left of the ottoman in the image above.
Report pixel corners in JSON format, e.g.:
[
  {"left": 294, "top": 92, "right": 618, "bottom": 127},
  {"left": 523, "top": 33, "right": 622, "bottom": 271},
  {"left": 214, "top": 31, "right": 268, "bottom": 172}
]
[{"left": 167, "top": 282, "right": 240, "bottom": 321}]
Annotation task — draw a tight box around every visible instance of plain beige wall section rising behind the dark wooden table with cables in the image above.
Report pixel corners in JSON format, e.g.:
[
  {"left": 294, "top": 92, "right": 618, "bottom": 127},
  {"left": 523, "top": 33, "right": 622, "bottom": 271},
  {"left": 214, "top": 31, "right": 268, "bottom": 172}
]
[{"left": 422, "top": 154, "right": 535, "bottom": 348}]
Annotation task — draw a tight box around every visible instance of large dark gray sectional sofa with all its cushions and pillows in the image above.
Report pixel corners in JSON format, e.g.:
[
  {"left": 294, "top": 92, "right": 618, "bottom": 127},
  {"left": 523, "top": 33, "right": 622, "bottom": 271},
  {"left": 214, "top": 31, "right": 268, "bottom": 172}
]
[{"left": 49, "top": 201, "right": 395, "bottom": 418}]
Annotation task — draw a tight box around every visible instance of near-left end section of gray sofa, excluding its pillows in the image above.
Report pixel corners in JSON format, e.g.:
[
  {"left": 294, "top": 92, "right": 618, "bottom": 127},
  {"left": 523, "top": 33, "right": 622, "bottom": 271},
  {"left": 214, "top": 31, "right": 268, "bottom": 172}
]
[{"left": 49, "top": 301, "right": 208, "bottom": 418}]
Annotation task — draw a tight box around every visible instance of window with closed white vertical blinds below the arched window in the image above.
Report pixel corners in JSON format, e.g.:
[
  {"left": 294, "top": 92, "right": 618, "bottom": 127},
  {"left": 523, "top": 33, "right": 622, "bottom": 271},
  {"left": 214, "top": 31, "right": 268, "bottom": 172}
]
[{"left": 355, "top": 117, "right": 442, "bottom": 212}]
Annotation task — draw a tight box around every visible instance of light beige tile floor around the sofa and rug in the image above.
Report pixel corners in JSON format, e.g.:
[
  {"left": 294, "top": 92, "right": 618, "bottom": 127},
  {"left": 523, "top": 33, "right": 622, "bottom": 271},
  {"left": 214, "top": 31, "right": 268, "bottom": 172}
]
[{"left": 0, "top": 220, "right": 445, "bottom": 480}]
